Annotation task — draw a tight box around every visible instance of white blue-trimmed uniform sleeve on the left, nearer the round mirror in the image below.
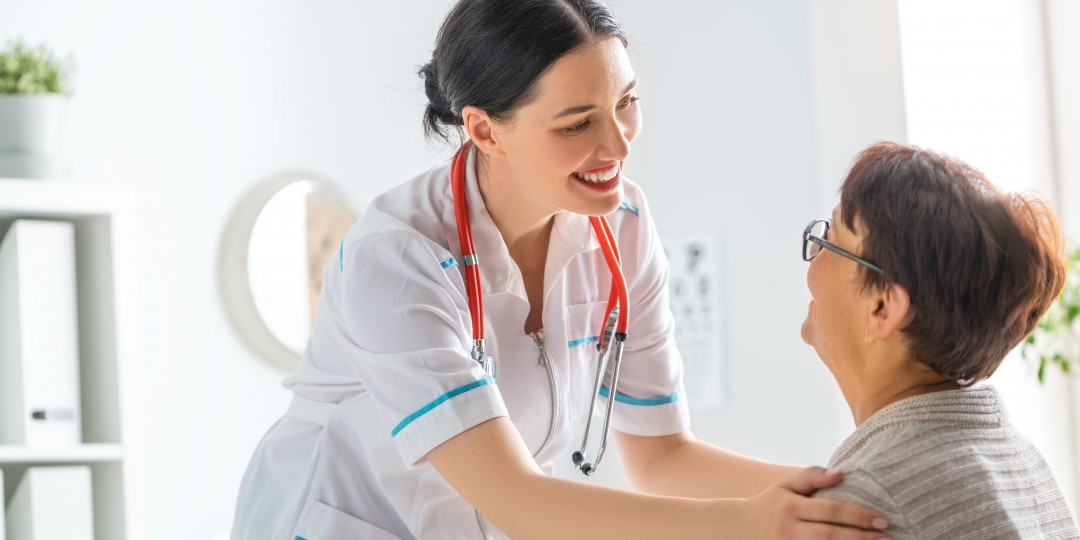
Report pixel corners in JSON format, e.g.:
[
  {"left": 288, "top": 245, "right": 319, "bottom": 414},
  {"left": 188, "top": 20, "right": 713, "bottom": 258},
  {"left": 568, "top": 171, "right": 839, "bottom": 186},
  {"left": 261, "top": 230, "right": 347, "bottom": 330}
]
[{"left": 332, "top": 231, "right": 507, "bottom": 467}]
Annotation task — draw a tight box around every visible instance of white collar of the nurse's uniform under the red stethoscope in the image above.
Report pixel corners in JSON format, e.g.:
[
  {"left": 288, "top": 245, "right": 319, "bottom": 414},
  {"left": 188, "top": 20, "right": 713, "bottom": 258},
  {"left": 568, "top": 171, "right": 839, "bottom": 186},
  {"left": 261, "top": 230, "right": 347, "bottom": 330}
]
[{"left": 443, "top": 146, "right": 599, "bottom": 298}]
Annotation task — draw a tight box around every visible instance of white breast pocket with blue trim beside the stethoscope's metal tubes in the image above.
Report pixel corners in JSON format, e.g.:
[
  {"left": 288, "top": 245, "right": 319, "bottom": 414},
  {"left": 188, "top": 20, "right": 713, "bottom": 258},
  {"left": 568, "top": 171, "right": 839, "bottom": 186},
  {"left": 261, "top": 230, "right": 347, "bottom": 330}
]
[{"left": 564, "top": 300, "right": 607, "bottom": 419}]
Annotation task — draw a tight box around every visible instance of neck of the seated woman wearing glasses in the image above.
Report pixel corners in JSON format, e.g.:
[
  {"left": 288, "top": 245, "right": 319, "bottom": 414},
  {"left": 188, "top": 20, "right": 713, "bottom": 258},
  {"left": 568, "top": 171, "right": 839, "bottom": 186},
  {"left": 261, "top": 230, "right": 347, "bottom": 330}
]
[{"left": 837, "top": 345, "right": 960, "bottom": 427}]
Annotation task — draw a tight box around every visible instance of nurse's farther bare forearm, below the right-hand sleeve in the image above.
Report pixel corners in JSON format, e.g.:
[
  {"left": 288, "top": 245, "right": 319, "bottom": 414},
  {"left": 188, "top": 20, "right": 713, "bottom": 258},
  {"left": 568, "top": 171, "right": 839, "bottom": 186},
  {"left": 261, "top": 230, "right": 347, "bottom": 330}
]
[{"left": 616, "top": 433, "right": 800, "bottom": 498}]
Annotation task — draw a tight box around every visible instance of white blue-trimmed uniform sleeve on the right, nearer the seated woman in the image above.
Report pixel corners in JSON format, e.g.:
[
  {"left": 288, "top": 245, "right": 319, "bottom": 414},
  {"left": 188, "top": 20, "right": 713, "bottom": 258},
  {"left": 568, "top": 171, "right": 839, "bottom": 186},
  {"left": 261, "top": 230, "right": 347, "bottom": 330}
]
[{"left": 612, "top": 187, "right": 690, "bottom": 436}]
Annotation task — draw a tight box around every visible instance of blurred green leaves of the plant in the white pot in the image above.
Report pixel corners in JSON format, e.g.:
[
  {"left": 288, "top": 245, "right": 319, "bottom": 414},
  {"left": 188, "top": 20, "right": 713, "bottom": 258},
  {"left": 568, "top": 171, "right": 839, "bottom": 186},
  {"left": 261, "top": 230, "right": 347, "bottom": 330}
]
[{"left": 0, "top": 39, "right": 72, "bottom": 94}]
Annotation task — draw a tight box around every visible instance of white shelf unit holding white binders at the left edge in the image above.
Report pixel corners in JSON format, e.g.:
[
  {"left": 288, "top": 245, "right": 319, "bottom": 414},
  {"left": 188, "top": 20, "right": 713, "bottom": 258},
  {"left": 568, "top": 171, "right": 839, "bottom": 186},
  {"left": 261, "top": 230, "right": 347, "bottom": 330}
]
[{"left": 0, "top": 178, "right": 141, "bottom": 540}]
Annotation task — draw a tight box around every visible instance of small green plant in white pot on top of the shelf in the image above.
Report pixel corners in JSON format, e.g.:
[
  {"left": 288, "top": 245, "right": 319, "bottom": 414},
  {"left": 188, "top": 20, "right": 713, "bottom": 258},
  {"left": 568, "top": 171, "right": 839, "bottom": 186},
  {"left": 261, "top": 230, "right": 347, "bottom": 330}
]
[{"left": 0, "top": 40, "right": 71, "bottom": 178}]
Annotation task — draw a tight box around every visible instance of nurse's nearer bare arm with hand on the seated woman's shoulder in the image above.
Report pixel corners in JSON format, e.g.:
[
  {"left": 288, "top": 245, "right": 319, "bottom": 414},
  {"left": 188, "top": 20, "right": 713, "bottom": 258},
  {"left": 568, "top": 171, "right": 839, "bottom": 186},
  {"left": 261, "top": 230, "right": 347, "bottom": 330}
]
[{"left": 428, "top": 417, "right": 882, "bottom": 540}]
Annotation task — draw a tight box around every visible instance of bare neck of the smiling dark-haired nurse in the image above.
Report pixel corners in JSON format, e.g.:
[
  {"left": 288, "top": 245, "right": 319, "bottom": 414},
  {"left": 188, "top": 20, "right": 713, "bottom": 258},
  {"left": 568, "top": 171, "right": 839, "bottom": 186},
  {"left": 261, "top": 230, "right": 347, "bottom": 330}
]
[{"left": 476, "top": 151, "right": 555, "bottom": 262}]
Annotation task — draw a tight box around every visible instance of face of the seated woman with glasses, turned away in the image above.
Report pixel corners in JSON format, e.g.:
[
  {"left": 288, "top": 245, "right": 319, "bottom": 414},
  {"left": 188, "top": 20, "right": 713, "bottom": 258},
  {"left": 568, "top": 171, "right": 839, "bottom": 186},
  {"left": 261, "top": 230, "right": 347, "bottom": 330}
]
[{"left": 801, "top": 207, "right": 869, "bottom": 379}]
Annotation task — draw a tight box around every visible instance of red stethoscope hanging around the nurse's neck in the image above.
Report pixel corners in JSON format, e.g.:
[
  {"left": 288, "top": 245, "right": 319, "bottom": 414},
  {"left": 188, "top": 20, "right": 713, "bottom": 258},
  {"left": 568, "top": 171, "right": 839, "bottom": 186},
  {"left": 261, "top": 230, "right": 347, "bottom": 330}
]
[{"left": 450, "top": 143, "right": 630, "bottom": 475}]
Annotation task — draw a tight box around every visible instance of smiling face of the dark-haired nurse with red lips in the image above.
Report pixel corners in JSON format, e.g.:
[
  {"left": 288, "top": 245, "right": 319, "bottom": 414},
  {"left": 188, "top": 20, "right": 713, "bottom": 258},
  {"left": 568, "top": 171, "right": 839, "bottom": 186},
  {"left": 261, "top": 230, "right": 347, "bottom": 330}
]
[{"left": 483, "top": 38, "right": 642, "bottom": 216}]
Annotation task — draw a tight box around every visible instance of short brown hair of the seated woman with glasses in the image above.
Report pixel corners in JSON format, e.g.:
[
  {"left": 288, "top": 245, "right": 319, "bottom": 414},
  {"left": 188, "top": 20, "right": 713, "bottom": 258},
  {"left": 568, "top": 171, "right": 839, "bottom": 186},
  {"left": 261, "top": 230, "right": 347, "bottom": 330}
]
[{"left": 840, "top": 143, "right": 1065, "bottom": 386}]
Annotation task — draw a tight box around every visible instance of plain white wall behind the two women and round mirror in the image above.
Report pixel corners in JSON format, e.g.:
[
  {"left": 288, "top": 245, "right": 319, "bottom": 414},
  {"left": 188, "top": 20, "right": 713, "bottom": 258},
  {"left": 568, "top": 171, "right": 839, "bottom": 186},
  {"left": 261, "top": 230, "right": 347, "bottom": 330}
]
[{"left": 0, "top": 0, "right": 904, "bottom": 540}]
